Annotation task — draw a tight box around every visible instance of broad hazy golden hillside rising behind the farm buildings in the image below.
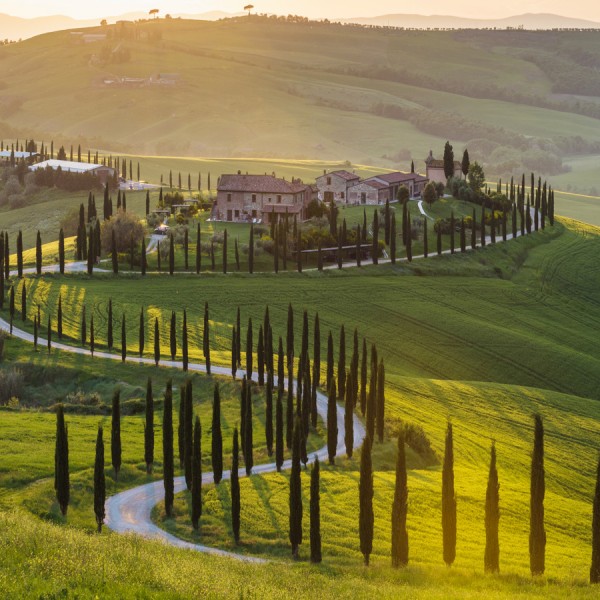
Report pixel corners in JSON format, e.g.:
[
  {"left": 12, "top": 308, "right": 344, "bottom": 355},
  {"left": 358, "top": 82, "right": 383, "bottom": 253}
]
[{"left": 0, "top": 17, "right": 600, "bottom": 194}]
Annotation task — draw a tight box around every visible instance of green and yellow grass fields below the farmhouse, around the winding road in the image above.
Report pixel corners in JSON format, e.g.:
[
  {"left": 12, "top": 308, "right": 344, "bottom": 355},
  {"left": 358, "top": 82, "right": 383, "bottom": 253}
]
[{"left": 0, "top": 214, "right": 600, "bottom": 598}]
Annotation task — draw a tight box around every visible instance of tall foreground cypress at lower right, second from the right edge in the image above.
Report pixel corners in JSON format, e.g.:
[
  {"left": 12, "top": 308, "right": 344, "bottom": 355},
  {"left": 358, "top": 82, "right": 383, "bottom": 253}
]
[{"left": 529, "top": 415, "right": 546, "bottom": 575}]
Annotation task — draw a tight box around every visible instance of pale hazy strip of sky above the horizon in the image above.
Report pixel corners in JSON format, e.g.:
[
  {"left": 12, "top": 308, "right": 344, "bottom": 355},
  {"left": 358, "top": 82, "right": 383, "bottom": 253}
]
[{"left": 0, "top": 0, "right": 600, "bottom": 20}]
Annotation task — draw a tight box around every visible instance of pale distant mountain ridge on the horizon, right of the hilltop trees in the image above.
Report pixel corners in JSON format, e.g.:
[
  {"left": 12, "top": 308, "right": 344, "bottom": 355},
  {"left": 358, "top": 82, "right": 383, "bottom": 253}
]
[{"left": 341, "top": 13, "right": 600, "bottom": 29}]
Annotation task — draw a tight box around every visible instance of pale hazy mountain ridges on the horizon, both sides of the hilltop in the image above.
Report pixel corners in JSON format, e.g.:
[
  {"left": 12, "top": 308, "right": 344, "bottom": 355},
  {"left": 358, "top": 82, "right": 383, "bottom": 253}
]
[{"left": 0, "top": 11, "right": 600, "bottom": 40}]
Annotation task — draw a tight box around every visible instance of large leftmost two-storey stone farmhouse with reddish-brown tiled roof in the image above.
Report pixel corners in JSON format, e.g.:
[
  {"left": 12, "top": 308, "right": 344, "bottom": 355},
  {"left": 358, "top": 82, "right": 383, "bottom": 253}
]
[{"left": 214, "top": 173, "right": 312, "bottom": 223}]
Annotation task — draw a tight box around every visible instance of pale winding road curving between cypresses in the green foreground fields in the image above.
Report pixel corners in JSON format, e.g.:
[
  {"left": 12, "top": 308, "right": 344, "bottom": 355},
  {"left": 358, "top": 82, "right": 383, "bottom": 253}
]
[{"left": 0, "top": 318, "right": 365, "bottom": 563}]
